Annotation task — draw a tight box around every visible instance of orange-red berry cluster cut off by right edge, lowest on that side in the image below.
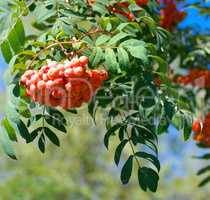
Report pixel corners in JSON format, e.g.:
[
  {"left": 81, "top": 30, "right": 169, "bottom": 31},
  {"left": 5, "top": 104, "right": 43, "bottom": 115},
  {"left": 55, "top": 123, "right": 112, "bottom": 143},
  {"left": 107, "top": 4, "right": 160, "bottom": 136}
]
[{"left": 192, "top": 113, "right": 210, "bottom": 146}]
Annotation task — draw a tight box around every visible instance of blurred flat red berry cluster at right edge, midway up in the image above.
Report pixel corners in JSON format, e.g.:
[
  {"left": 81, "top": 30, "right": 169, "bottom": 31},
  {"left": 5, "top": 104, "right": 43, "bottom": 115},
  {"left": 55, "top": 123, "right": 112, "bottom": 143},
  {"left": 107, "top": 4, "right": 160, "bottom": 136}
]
[{"left": 176, "top": 69, "right": 210, "bottom": 88}]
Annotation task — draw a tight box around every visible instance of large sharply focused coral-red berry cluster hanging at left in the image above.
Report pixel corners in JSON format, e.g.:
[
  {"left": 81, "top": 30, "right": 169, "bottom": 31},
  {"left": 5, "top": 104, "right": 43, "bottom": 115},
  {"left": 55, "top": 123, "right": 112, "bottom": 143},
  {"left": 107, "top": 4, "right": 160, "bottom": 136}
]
[{"left": 21, "top": 56, "right": 108, "bottom": 109}]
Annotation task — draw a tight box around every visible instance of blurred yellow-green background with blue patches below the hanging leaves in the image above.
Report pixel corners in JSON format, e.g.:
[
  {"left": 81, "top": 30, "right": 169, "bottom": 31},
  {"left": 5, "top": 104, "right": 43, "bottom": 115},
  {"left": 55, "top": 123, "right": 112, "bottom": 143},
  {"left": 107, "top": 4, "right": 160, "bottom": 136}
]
[{"left": 0, "top": 90, "right": 210, "bottom": 200}]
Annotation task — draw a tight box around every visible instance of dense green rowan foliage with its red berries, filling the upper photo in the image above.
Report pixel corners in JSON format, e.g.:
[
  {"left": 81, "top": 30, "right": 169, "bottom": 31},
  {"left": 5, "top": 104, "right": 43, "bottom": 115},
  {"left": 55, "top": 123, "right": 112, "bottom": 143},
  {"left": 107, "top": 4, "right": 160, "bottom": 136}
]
[{"left": 0, "top": 0, "right": 210, "bottom": 192}]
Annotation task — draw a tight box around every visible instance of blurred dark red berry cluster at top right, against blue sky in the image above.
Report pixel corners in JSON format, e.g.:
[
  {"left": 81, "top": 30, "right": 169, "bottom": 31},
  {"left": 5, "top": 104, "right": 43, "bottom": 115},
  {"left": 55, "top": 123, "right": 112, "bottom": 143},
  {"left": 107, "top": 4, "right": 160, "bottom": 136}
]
[{"left": 160, "top": 0, "right": 186, "bottom": 31}]
